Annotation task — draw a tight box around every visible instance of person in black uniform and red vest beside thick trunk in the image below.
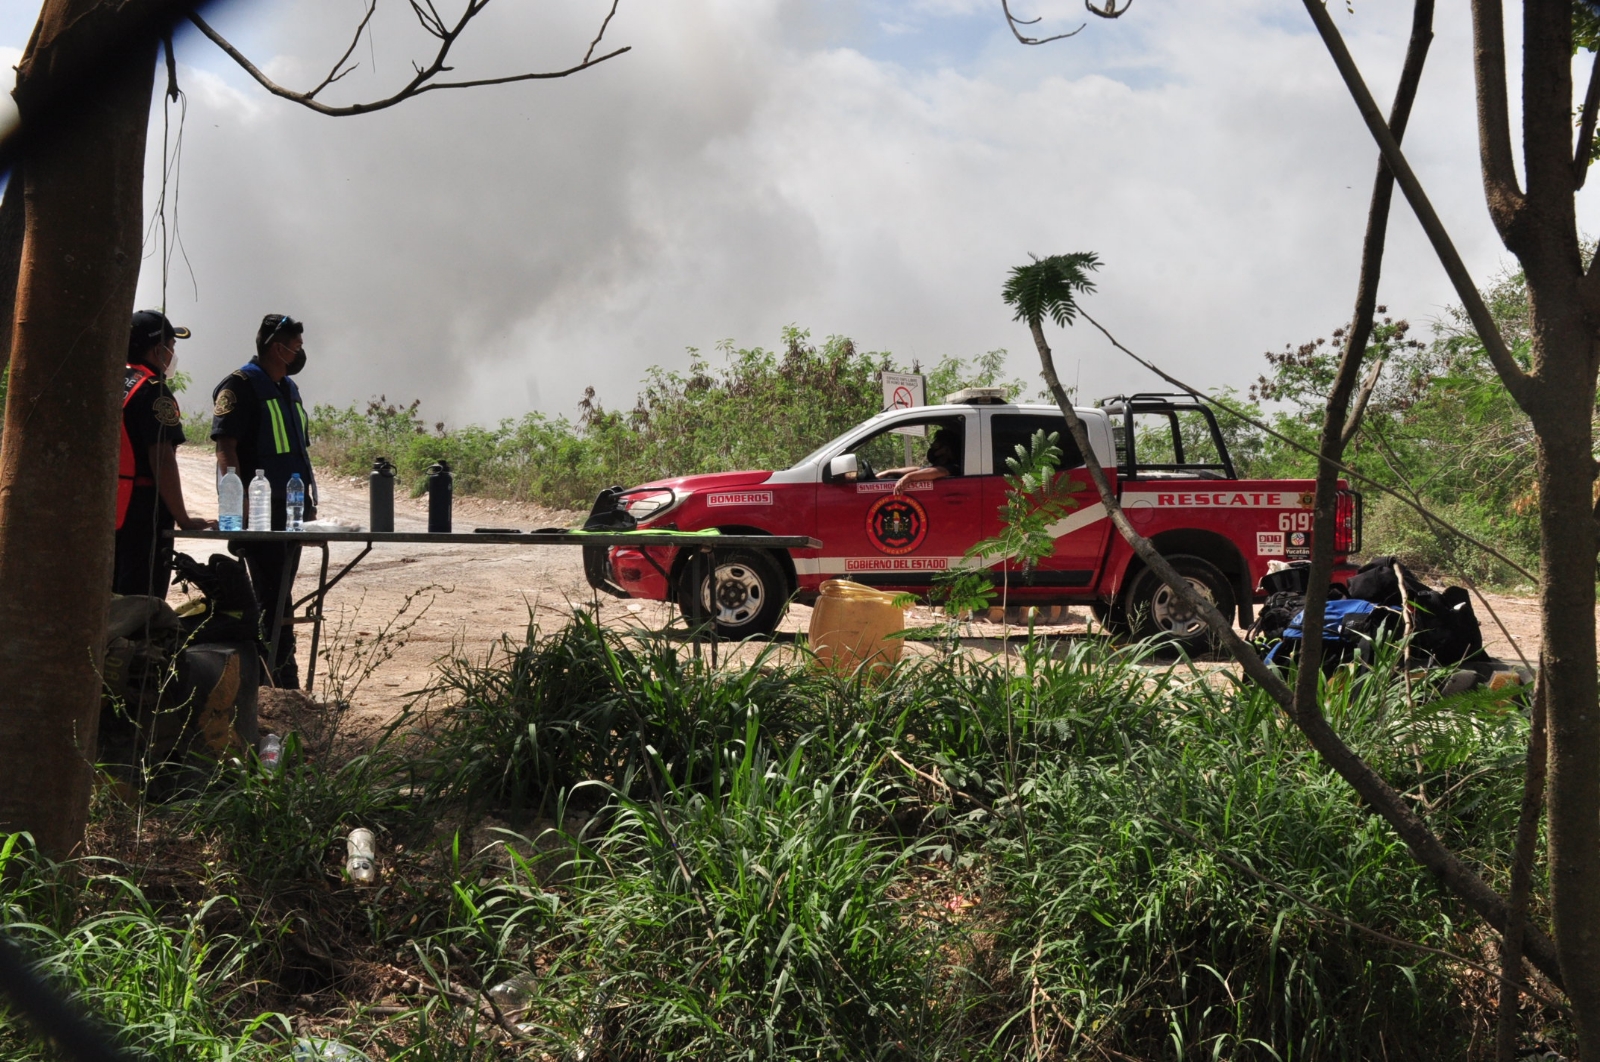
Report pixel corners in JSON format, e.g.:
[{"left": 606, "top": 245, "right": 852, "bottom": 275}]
[{"left": 112, "top": 310, "right": 216, "bottom": 598}]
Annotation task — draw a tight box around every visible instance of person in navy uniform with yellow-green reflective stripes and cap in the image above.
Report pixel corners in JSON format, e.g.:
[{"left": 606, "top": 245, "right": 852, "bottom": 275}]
[{"left": 211, "top": 313, "right": 317, "bottom": 689}]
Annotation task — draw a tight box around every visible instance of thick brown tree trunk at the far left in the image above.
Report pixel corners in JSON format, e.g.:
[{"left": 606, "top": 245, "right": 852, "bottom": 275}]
[{"left": 0, "top": 0, "right": 155, "bottom": 856}]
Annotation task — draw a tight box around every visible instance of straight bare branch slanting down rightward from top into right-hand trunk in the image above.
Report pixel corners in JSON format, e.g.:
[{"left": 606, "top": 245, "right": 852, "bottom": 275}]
[{"left": 1304, "top": 0, "right": 1538, "bottom": 409}]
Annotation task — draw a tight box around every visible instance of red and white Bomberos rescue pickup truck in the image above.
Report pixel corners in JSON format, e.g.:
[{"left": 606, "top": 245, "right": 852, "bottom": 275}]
[{"left": 584, "top": 389, "right": 1362, "bottom": 648}]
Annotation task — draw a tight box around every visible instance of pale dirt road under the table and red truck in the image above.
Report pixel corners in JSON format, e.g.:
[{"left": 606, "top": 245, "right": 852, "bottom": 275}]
[{"left": 173, "top": 445, "right": 1539, "bottom": 721}]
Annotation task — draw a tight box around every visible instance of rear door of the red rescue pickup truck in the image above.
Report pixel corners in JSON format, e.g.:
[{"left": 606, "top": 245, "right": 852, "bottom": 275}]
[{"left": 982, "top": 411, "right": 1110, "bottom": 593}]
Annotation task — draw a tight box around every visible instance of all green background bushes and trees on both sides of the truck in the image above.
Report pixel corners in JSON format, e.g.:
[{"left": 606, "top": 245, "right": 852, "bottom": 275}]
[{"left": 294, "top": 265, "right": 1568, "bottom": 585}]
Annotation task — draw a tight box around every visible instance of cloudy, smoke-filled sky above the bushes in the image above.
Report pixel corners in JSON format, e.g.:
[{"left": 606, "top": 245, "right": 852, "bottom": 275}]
[{"left": 0, "top": 0, "right": 1597, "bottom": 424}]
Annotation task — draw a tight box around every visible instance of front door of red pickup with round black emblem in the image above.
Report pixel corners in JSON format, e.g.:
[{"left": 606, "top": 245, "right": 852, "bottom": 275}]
[{"left": 816, "top": 411, "right": 982, "bottom": 590}]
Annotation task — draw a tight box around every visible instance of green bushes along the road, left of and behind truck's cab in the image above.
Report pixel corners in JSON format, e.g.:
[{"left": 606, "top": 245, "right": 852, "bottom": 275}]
[{"left": 312, "top": 328, "right": 1022, "bottom": 509}]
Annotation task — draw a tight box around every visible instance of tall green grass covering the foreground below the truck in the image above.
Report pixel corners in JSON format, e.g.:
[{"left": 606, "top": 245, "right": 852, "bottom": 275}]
[{"left": 0, "top": 617, "right": 1566, "bottom": 1060}]
